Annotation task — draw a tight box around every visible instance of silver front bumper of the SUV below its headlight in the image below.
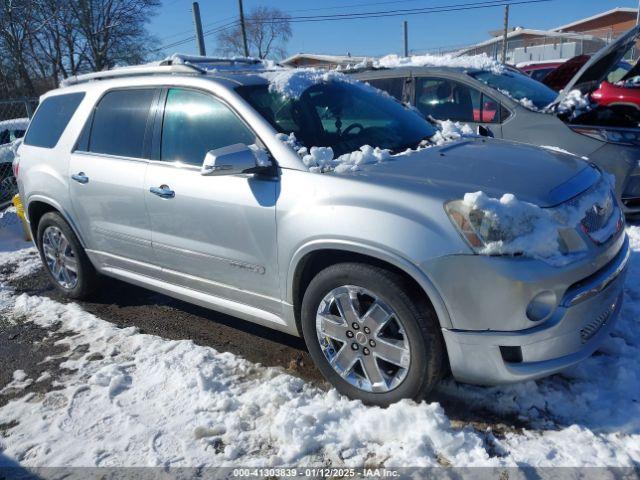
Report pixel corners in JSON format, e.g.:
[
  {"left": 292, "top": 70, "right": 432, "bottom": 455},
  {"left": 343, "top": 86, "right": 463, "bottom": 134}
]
[{"left": 442, "top": 235, "right": 629, "bottom": 385}]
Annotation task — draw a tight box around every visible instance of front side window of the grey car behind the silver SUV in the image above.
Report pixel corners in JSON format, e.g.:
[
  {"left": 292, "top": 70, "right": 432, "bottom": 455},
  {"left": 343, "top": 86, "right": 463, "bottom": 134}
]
[{"left": 416, "top": 78, "right": 481, "bottom": 122}]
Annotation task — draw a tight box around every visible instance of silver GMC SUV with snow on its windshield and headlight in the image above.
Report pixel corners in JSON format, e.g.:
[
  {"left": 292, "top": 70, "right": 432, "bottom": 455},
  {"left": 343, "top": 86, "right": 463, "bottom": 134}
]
[{"left": 15, "top": 59, "right": 629, "bottom": 405}]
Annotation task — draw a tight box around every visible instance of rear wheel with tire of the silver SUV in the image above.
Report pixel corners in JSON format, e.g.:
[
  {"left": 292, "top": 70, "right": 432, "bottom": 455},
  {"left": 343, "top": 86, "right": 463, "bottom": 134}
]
[{"left": 36, "top": 212, "right": 98, "bottom": 299}]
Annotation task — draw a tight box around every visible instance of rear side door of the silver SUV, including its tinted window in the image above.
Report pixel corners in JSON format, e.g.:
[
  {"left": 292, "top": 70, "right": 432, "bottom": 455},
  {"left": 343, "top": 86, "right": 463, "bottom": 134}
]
[{"left": 69, "top": 88, "right": 160, "bottom": 270}]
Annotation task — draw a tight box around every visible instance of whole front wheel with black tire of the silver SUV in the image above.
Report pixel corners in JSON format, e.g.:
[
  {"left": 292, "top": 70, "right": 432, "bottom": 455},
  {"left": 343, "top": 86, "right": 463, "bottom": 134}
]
[{"left": 301, "top": 263, "right": 444, "bottom": 406}]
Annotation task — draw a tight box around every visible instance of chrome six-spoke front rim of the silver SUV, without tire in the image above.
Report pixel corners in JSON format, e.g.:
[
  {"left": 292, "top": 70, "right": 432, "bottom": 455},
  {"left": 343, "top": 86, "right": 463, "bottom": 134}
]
[{"left": 316, "top": 285, "right": 411, "bottom": 393}]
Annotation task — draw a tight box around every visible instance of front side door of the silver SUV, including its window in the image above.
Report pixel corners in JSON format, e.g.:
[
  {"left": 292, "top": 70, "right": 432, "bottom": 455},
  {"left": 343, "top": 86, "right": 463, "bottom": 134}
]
[{"left": 144, "top": 88, "right": 280, "bottom": 304}]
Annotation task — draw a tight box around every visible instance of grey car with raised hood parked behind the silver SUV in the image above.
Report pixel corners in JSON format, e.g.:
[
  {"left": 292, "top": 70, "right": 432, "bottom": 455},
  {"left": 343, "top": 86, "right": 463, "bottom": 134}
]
[{"left": 352, "top": 27, "right": 640, "bottom": 215}]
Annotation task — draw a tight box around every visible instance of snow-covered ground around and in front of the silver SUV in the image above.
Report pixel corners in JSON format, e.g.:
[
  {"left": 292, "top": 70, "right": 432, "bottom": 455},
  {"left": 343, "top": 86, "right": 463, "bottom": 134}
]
[{"left": 0, "top": 209, "right": 640, "bottom": 467}]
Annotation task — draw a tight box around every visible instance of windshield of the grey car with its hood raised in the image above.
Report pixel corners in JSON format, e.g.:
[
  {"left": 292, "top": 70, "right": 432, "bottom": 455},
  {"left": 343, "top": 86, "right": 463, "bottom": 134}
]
[{"left": 469, "top": 71, "right": 558, "bottom": 109}]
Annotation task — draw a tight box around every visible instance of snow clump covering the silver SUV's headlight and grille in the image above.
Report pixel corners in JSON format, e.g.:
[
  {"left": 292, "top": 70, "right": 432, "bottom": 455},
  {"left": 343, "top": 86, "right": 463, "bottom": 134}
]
[{"left": 463, "top": 178, "right": 619, "bottom": 265}]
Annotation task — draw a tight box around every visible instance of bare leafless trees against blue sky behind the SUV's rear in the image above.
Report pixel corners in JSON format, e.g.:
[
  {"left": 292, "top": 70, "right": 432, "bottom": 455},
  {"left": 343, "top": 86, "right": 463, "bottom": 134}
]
[{"left": 0, "top": 0, "right": 160, "bottom": 96}]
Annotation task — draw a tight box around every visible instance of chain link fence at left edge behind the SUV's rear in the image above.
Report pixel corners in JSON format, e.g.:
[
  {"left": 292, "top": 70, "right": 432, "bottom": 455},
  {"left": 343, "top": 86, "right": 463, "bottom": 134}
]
[{"left": 0, "top": 98, "right": 38, "bottom": 209}]
